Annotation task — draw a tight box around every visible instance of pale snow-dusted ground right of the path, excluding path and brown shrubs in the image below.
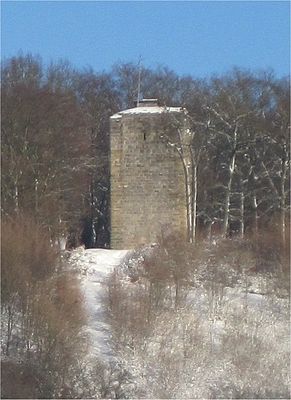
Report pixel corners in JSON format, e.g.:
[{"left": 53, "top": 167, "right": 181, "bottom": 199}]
[{"left": 102, "top": 249, "right": 290, "bottom": 398}]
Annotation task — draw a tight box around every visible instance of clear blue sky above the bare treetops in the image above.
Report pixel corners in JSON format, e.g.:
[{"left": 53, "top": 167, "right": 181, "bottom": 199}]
[{"left": 1, "top": 1, "right": 290, "bottom": 77}]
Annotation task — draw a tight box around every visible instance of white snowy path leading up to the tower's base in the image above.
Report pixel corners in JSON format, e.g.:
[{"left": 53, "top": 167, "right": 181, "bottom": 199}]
[{"left": 70, "top": 249, "right": 128, "bottom": 362}]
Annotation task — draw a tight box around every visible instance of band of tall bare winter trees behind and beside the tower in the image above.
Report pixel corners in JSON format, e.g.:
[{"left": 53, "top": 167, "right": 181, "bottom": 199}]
[{"left": 1, "top": 55, "right": 290, "bottom": 247}]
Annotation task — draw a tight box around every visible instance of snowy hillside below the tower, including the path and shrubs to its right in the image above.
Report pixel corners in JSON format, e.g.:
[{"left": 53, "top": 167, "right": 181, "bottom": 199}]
[{"left": 71, "top": 239, "right": 289, "bottom": 398}]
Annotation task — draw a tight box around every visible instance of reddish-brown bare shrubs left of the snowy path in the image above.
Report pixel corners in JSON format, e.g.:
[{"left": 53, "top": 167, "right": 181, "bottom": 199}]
[{"left": 2, "top": 217, "right": 86, "bottom": 398}]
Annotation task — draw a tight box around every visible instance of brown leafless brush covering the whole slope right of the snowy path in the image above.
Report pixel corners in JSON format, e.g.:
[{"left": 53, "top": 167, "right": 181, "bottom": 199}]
[{"left": 108, "top": 235, "right": 289, "bottom": 398}]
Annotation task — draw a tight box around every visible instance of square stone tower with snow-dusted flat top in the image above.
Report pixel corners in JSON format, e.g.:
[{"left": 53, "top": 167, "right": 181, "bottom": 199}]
[{"left": 110, "top": 99, "right": 186, "bottom": 249}]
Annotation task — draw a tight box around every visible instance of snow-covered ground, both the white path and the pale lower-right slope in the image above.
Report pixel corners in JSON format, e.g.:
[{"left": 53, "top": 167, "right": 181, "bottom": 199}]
[{"left": 70, "top": 248, "right": 290, "bottom": 398}]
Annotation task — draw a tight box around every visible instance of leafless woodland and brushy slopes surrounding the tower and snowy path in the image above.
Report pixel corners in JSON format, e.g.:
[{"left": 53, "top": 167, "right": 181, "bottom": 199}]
[{"left": 1, "top": 54, "right": 290, "bottom": 398}]
